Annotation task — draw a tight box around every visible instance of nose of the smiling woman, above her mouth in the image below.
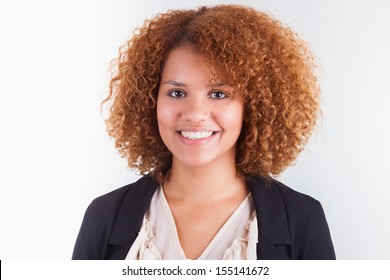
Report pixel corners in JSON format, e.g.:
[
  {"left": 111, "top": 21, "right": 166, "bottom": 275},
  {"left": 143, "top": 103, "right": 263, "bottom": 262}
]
[{"left": 182, "top": 96, "right": 210, "bottom": 123}]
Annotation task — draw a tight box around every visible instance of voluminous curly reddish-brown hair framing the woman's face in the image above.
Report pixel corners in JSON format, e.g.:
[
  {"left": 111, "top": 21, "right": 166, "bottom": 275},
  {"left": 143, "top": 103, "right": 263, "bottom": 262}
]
[{"left": 103, "top": 5, "right": 320, "bottom": 182}]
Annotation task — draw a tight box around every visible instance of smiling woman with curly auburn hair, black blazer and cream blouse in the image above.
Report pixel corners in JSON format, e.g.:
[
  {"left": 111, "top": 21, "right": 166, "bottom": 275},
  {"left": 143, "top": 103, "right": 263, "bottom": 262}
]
[{"left": 73, "top": 5, "right": 335, "bottom": 259}]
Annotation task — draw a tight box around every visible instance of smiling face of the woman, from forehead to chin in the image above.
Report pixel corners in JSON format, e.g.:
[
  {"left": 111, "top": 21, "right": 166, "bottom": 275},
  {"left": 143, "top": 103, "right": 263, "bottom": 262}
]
[{"left": 157, "top": 47, "right": 244, "bottom": 167}]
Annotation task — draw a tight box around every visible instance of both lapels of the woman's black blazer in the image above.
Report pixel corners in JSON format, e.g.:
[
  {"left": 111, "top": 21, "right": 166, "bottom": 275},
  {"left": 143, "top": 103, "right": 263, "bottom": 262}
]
[{"left": 109, "top": 176, "right": 291, "bottom": 245}]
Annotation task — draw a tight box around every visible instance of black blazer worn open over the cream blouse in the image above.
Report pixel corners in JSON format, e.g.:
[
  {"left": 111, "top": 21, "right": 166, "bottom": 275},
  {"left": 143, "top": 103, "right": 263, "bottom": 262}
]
[{"left": 72, "top": 176, "right": 336, "bottom": 260}]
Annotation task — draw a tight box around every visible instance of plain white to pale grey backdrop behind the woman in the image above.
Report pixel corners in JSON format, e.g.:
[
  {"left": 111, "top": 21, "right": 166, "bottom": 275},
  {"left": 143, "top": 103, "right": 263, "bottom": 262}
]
[{"left": 0, "top": 0, "right": 390, "bottom": 259}]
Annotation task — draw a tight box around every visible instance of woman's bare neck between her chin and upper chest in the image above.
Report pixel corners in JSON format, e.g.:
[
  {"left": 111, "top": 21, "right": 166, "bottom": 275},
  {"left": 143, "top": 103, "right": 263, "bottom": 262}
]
[{"left": 164, "top": 160, "right": 248, "bottom": 203}]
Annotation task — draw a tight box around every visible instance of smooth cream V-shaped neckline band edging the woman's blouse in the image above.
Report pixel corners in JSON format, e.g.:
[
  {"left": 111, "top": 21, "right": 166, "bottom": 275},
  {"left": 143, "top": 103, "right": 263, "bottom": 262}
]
[{"left": 159, "top": 186, "right": 251, "bottom": 260}]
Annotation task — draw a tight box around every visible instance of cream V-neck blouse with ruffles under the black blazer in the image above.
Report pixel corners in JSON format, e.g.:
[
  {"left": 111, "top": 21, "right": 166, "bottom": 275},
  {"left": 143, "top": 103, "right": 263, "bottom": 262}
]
[{"left": 126, "top": 186, "right": 258, "bottom": 260}]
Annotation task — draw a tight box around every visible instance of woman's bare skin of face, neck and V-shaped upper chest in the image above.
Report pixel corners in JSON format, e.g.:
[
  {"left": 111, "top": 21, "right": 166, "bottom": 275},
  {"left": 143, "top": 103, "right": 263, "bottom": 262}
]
[{"left": 157, "top": 46, "right": 248, "bottom": 259}]
